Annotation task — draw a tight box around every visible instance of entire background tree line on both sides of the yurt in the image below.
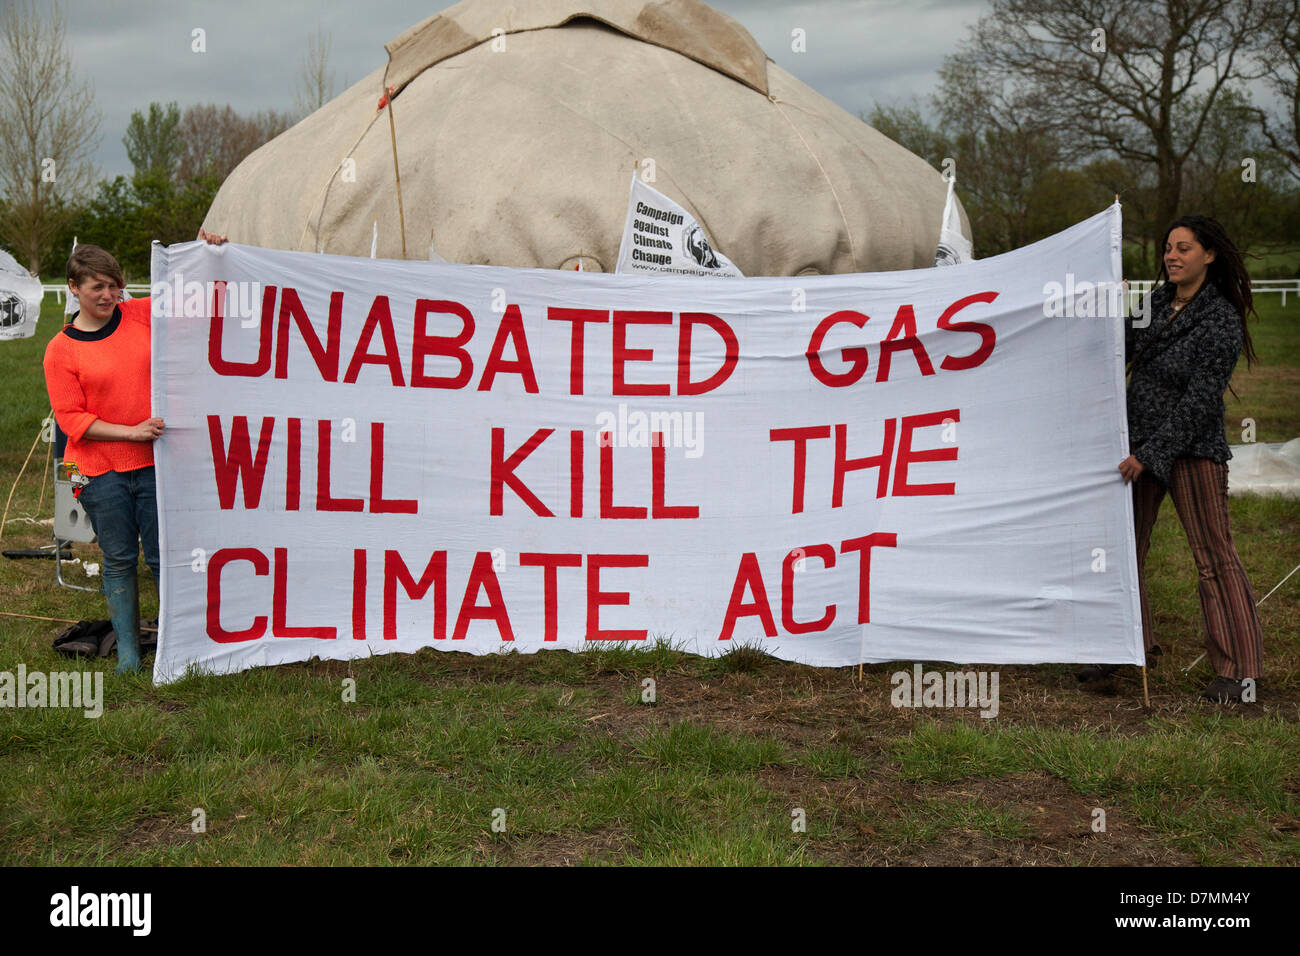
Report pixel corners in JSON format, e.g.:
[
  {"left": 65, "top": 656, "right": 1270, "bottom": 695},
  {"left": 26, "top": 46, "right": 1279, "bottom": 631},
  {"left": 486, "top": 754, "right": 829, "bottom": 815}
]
[{"left": 0, "top": 0, "right": 1300, "bottom": 278}]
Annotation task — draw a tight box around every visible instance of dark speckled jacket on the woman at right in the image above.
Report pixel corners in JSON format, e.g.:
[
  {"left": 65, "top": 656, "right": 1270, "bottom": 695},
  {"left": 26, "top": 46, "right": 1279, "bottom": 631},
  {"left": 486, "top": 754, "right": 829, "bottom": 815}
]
[{"left": 1125, "top": 280, "right": 1244, "bottom": 485}]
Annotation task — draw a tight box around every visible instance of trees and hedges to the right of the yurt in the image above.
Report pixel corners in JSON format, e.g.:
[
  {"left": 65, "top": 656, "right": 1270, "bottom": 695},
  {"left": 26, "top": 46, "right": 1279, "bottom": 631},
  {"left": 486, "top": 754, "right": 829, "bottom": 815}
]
[{"left": 863, "top": 0, "right": 1300, "bottom": 278}]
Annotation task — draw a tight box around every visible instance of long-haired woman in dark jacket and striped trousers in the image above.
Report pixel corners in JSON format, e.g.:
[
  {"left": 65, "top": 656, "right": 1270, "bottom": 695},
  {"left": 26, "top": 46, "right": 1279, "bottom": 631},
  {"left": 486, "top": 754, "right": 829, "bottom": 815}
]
[{"left": 1079, "top": 216, "right": 1264, "bottom": 702}]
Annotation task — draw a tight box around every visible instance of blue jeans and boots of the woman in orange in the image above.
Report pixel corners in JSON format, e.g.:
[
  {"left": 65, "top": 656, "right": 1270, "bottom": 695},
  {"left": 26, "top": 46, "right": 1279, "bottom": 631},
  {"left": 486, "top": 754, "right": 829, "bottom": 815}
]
[{"left": 78, "top": 466, "right": 161, "bottom": 670}]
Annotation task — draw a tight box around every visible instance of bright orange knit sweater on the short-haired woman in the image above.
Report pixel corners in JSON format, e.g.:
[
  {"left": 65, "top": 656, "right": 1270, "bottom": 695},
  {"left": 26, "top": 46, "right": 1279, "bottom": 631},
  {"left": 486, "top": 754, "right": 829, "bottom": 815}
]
[{"left": 44, "top": 298, "right": 153, "bottom": 476}]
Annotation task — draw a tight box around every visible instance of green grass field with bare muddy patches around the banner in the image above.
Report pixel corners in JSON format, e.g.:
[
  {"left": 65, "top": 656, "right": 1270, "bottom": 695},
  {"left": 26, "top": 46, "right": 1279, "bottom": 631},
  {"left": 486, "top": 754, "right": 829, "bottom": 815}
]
[{"left": 0, "top": 297, "right": 1300, "bottom": 865}]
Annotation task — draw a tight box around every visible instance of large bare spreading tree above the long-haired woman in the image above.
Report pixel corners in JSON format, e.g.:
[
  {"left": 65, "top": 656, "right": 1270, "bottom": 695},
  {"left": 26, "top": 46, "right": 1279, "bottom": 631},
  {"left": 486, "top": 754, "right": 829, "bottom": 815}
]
[{"left": 949, "top": 0, "right": 1268, "bottom": 230}]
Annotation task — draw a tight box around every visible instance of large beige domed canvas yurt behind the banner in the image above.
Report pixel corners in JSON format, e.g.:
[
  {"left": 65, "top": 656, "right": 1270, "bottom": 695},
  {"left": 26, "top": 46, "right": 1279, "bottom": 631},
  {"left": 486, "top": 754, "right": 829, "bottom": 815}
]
[{"left": 204, "top": 0, "right": 969, "bottom": 276}]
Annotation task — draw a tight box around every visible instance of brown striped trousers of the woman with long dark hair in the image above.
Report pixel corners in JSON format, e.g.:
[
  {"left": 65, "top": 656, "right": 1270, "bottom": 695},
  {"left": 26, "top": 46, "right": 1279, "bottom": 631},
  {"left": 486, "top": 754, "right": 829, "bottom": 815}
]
[{"left": 1134, "top": 458, "right": 1264, "bottom": 680}]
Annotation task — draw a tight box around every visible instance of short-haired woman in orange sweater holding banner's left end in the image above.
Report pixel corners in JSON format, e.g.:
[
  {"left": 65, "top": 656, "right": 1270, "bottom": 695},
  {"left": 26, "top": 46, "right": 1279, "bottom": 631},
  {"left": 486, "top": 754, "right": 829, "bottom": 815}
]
[{"left": 44, "top": 230, "right": 225, "bottom": 674}]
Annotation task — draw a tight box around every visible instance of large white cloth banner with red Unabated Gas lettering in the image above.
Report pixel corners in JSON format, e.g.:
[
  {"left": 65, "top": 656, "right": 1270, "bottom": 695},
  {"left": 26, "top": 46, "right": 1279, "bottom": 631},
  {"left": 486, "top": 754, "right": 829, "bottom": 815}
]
[{"left": 153, "top": 206, "right": 1143, "bottom": 682}]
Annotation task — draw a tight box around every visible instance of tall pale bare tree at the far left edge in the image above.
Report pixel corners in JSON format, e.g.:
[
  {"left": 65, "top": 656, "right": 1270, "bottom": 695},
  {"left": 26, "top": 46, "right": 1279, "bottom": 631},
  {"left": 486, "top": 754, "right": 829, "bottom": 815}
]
[{"left": 0, "top": 0, "right": 100, "bottom": 272}]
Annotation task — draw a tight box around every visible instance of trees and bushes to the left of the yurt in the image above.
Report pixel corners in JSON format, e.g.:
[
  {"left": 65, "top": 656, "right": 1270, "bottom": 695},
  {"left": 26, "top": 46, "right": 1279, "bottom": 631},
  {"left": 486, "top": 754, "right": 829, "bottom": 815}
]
[{"left": 0, "top": 0, "right": 314, "bottom": 281}]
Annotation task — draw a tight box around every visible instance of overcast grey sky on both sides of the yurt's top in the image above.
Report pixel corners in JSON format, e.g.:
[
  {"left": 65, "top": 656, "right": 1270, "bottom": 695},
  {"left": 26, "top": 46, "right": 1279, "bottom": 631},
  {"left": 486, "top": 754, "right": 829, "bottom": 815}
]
[{"left": 62, "top": 0, "right": 989, "bottom": 176}]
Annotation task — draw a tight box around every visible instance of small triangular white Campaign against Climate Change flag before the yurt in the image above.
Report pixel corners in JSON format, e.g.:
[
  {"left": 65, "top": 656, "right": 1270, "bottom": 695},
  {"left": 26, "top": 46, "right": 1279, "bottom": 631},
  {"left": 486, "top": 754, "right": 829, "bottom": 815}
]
[{"left": 614, "top": 173, "right": 741, "bottom": 278}]
